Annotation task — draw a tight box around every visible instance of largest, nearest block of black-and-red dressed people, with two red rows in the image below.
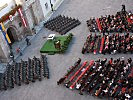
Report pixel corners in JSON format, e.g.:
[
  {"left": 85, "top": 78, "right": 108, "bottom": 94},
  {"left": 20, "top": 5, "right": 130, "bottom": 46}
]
[{"left": 57, "top": 58, "right": 133, "bottom": 100}]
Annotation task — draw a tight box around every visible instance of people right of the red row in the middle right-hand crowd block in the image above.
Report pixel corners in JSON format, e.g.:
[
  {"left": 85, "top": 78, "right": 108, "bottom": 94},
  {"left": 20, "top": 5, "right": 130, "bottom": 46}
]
[{"left": 102, "top": 33, "right": 133, "bottom": 54}]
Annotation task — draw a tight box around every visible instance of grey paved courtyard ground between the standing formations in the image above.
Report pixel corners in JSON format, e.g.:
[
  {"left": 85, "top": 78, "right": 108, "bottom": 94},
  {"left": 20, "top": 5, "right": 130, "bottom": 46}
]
[{"left": 0, "top": 0, "right": 133, "bottom": 100}]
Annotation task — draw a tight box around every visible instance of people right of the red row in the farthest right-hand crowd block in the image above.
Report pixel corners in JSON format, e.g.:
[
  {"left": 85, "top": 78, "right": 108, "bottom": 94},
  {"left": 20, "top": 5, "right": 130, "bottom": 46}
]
[{"left": 99, "top": 12, "right": 133, "bottom": 33}]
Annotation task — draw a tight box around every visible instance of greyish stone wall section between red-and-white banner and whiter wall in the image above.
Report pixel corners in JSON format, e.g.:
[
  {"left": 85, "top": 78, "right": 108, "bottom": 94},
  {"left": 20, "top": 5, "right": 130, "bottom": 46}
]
[{"left": 22, "top": 0, "right": 44, "bottom": 30}]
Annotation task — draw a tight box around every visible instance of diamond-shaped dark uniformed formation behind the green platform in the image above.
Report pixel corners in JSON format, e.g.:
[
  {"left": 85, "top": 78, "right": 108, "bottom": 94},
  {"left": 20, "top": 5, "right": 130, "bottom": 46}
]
[{"left": 44, "top": 15, "right": 81, "bottom": 35}]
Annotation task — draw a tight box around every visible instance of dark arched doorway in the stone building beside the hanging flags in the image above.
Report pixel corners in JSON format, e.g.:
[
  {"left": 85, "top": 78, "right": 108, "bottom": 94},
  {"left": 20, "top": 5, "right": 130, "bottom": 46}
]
[{"left": 7, "top": 27, "right": 16, "bottom": 44}]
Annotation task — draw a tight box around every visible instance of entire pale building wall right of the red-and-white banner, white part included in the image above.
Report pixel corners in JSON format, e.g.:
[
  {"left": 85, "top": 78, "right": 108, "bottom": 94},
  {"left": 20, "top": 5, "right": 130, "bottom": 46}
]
[{"left": 20, "top": 0, "right": 63, "bottom": 30}]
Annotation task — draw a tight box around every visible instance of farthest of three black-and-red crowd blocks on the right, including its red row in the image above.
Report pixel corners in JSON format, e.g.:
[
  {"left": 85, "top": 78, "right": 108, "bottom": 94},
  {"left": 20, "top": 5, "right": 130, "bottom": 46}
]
[{"left": 87, "top": 11, "right": 133, "bottom": 33}]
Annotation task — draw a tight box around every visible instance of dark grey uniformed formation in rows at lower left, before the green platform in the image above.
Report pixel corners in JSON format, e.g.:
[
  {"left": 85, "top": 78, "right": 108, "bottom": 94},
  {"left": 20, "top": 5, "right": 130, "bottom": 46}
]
[{"left": 0, "top": 55, "right": 49, "bottom": 90}]
